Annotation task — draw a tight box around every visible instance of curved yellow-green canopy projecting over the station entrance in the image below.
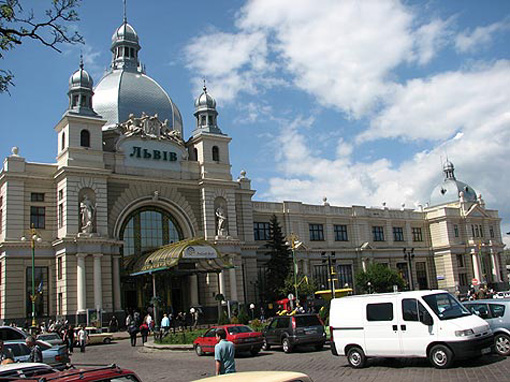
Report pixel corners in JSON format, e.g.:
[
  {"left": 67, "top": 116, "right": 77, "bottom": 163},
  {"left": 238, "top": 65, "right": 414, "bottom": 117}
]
[{"left": 131, "top": 239, "right": 233, "bottom": 276}]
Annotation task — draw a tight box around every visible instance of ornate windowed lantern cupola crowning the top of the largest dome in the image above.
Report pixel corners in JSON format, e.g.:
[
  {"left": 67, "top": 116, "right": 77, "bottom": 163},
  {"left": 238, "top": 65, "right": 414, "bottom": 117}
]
[{"left": 110, "top": 13, "right": 143, "bottom": 72}]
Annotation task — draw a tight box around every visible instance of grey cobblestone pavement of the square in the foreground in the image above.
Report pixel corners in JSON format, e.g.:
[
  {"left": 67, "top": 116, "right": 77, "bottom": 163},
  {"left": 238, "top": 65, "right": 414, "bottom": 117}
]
[{"left": 72, "top": 340, "right": 510, "bottom": 382}]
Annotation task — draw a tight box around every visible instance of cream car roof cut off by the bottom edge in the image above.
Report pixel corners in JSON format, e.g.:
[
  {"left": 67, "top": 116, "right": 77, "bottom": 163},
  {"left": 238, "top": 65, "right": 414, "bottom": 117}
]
[{"left": 193, "top": 371, "right": 313, "bottom": 382}]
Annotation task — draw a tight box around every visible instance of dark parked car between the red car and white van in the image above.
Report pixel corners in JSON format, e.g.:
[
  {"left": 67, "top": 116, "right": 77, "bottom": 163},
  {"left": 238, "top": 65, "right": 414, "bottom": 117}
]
[{"left": 262, "top": 314, "right": 326, "bottom": 353}]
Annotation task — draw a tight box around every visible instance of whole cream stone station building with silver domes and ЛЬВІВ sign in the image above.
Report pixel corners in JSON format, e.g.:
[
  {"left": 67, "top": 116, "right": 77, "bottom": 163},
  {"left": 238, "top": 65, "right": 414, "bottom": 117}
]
[{"left": 0, "top": 20, "right": 506, "bottom": 321}]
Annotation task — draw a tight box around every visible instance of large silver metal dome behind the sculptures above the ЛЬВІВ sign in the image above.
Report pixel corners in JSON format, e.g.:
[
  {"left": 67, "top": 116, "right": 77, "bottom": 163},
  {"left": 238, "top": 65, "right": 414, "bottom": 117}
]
[{"left": 94, "top": 70, "right": 183, "bottom": 136}]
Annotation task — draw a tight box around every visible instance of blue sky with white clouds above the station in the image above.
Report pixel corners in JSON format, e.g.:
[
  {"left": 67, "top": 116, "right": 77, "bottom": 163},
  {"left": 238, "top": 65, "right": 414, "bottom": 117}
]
[{"left": 0, "top": 0, "right": 510, "bottom": 239}]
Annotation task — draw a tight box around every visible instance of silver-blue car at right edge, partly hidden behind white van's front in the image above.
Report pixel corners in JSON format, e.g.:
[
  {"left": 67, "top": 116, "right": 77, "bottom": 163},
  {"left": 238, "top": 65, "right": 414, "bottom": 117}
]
[{"left": 464, "top": 299, "right": 510, "bottom": 356}]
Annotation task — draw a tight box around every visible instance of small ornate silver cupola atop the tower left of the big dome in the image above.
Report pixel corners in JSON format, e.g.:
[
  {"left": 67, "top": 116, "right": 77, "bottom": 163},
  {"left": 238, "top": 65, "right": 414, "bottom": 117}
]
[{"left": 67, "top": 56, "right": 97, "bottom": 116}]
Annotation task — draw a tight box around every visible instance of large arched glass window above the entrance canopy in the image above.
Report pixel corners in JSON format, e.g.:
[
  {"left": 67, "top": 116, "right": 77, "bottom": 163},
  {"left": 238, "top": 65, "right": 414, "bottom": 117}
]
[{"left": 120, "top": 207, "right": 184, "bottom": 256}]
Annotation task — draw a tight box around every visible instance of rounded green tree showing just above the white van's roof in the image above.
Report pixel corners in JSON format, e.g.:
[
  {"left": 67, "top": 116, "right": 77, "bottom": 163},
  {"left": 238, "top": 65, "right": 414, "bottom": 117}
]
[{"left": 356, "top": 263, "right": 405, "bottom": 293}]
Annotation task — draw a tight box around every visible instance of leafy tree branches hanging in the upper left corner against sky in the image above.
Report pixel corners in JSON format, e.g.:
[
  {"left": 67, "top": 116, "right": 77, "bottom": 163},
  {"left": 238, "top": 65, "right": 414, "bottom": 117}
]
[{"left": 0, "top": 0, "right": 83, "bottom": 93}]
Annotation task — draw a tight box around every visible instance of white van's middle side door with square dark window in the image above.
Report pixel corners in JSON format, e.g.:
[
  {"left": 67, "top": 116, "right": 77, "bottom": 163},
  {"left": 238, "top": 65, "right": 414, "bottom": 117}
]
[{"left": 364, "top": 298, "right": 402, "bottom": 356}]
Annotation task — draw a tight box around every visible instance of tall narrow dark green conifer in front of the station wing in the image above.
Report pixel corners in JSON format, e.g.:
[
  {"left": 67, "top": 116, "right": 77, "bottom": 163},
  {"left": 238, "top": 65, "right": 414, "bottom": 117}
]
[{"left": 265, "top": 215, "right": 292, "bottom": 301}]
